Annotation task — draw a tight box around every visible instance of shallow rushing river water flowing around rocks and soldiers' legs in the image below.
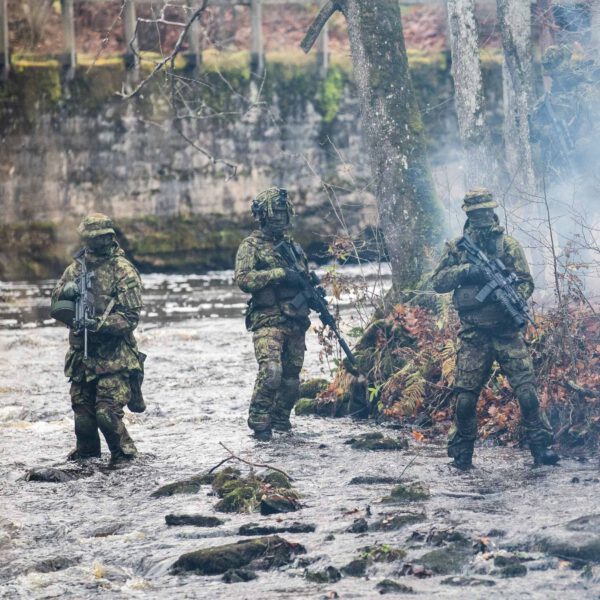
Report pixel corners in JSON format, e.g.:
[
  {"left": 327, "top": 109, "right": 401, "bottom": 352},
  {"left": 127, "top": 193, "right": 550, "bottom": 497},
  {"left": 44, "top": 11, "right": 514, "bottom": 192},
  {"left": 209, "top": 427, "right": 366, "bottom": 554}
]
[{"left": 0, "top": 273, "right": 600, "bottom": 599}]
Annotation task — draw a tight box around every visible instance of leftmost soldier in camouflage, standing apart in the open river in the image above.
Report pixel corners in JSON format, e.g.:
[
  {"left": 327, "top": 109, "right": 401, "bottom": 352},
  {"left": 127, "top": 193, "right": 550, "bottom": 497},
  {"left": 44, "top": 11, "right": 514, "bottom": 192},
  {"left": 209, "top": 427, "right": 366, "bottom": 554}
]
[{"left": 52, "top": 213, "right": 145, "bottom": 463}]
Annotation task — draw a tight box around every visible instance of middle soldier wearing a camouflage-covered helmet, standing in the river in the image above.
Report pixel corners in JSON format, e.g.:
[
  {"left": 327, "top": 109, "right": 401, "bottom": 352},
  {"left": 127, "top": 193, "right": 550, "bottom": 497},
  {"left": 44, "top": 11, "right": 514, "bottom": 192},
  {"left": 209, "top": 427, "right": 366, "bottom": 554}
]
[{"left": 235, "top": 187, "right": 310, "bottom": 440}]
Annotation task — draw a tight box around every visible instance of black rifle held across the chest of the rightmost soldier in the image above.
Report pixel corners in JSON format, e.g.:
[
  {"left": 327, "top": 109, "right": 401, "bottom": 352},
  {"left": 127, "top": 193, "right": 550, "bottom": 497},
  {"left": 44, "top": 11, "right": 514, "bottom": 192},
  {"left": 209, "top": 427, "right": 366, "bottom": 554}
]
[{"left": 456, "top": 235, "right": 536, "bottom": 328}]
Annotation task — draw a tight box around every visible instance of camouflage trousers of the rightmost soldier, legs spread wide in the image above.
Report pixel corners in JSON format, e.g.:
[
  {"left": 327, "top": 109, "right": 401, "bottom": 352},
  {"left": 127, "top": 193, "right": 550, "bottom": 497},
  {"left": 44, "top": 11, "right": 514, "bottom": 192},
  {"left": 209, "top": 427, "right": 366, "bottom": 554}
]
[{"left": 448, "top": 328, "right": 553, "bottom": 456}]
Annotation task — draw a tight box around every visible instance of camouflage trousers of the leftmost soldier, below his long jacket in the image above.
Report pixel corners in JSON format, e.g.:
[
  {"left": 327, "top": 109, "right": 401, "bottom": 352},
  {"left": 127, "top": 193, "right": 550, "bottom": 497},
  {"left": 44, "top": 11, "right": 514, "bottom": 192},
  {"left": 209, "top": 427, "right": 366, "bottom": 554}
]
[{"left": 70, "top": 372, "right": 137, "bottom": 457}]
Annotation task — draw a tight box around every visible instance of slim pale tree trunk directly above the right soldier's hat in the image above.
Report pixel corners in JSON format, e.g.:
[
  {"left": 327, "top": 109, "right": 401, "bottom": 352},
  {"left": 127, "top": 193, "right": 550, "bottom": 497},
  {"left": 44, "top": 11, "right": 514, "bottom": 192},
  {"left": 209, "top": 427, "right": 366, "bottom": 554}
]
[{"left": 448, "top": 0, "right": 497, "bottom": 188}]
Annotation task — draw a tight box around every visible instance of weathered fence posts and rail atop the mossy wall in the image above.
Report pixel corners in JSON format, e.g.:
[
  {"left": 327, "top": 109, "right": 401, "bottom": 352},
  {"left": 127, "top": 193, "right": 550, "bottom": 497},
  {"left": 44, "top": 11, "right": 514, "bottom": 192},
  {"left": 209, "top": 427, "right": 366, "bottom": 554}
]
[{"left": 0, "top": 0, "right": 445, "bottom": 79}]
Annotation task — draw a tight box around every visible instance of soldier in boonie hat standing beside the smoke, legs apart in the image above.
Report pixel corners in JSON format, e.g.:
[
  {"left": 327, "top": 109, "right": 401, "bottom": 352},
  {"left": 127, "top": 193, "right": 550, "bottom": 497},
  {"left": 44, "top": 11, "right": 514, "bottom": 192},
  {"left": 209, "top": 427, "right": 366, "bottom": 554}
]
[{"left": 432, "top": 188, "right": 558, "bottom": 470}]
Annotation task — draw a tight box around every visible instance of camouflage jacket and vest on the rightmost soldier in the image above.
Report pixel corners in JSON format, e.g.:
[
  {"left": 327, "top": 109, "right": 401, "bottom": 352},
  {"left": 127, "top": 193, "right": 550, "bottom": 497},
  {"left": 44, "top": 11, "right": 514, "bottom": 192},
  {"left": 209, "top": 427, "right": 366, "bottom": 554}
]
[{"left": 431, "top": 227, "right": 534, "bottom": 328}]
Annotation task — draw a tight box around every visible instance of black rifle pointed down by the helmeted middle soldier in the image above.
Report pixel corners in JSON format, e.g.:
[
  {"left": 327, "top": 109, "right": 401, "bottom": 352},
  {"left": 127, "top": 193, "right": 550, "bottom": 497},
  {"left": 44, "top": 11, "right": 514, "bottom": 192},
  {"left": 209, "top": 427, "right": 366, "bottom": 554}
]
[{"left": 275, "top": 240, "right": 356, "bottom": 368}]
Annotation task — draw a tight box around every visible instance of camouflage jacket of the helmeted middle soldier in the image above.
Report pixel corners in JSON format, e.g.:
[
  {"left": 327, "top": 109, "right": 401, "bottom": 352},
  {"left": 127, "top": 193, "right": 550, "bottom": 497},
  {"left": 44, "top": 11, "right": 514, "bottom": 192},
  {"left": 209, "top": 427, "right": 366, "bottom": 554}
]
[{"left": 235, "top": 230, "right": 310, "bottom": 331}]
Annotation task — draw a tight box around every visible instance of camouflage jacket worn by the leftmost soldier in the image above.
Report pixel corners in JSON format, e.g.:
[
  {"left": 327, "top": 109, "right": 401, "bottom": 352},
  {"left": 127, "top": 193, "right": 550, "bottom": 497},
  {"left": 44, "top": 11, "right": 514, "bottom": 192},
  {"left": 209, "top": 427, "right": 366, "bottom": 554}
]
[{"left": 52, "top": 246, "right": 142, "bottom": 381}]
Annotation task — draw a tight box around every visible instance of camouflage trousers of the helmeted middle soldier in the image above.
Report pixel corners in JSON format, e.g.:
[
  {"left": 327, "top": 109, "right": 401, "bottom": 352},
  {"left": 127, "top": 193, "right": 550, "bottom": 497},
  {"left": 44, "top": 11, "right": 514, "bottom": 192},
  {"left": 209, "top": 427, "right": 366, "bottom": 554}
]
[{"left": 248, "top": 325, "right": 306, "bottom": 431}]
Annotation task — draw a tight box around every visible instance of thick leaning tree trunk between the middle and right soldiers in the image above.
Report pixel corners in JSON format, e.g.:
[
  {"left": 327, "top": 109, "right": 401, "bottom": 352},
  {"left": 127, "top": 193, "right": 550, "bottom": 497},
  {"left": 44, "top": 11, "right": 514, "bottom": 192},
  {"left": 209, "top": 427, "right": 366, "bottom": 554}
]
[{"left": 339, "top": 0, "right": 442, "bottom": 294}]
